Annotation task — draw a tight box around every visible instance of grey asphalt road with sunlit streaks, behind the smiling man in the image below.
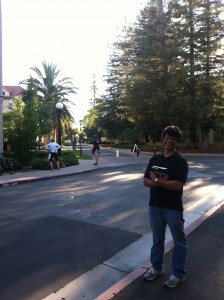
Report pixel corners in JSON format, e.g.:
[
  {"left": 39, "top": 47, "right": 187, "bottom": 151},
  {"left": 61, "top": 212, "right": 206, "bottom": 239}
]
[{"left": 0, "top": 151, "right": 224, "bottom": 300}]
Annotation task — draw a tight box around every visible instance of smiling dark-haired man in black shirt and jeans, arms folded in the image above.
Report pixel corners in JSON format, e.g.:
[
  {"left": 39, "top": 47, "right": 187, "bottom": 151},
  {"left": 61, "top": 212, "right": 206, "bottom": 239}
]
[{"left": 144, "top": 126, "right": 188, "bottom": 288}]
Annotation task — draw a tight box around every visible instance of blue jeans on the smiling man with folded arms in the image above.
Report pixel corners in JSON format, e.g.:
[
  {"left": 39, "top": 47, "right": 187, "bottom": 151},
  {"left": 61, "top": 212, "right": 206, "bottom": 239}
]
[{"left": 149, "top": 205, "right": 187, "bottom": 278}]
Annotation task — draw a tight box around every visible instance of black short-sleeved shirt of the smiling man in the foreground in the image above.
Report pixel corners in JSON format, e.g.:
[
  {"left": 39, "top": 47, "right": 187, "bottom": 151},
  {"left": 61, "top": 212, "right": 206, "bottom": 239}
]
[{"left": 144, "top": 152, "right": 188, "bottom": 211}]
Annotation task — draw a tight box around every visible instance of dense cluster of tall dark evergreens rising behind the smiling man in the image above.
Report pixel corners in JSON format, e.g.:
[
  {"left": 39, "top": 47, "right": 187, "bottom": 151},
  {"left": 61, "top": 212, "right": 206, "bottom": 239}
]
[{"left": 101, "top": 0, "right": 224, "bottom": 142}]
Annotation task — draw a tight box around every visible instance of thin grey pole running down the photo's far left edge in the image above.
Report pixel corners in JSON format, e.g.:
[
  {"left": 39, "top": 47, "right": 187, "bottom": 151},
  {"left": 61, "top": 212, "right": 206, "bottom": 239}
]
[{"left": 0, "top": 0, "right": 3, "bottom": 157}]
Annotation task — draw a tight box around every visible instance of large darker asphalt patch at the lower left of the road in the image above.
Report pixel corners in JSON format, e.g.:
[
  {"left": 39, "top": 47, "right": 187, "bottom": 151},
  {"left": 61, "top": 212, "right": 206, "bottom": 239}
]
[{"left": 0, "top": 216, "right": 141, "bottom": 300}]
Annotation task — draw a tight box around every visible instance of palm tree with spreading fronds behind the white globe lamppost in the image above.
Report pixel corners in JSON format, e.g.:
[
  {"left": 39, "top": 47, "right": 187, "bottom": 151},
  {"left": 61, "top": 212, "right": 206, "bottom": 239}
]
[{"left": 20, "top": 62, "right": 76, "bottom": 141}]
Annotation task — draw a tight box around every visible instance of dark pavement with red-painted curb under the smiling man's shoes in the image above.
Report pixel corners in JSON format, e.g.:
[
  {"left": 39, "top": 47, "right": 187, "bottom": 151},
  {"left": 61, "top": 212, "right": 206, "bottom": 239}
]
[{"left": 95, "top": 201, "right": 224, "bottom": 300}]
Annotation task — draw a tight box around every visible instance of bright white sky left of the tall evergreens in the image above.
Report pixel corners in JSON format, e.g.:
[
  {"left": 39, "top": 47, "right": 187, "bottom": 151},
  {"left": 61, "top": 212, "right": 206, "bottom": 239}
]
[{"left": 1, "top": 0, "right": 147, "bottom": 125}]
